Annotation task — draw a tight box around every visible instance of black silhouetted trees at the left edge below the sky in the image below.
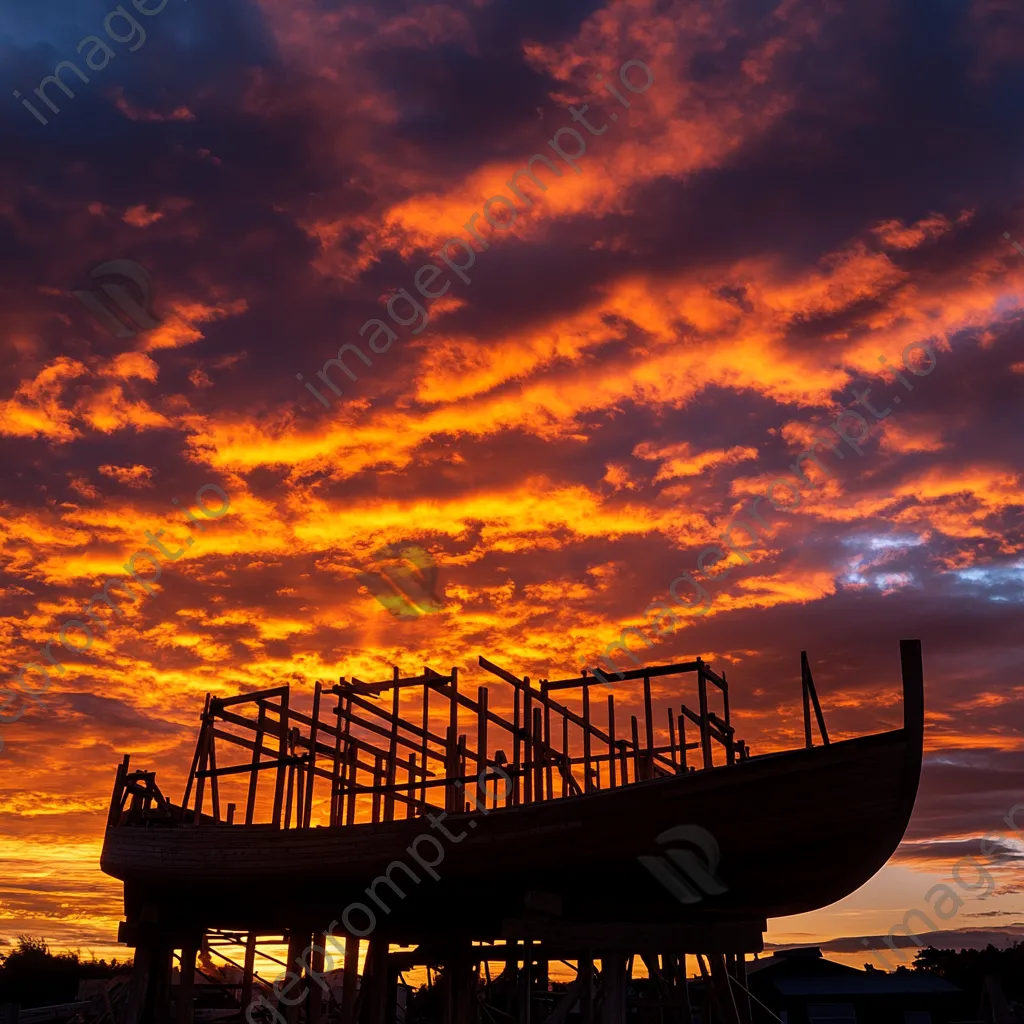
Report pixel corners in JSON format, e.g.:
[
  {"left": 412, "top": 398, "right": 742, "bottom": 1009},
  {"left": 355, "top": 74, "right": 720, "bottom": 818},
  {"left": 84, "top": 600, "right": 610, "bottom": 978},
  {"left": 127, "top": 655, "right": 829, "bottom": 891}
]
[{"left": 0, "top": 935, "right": 131, "bottom": 1009}]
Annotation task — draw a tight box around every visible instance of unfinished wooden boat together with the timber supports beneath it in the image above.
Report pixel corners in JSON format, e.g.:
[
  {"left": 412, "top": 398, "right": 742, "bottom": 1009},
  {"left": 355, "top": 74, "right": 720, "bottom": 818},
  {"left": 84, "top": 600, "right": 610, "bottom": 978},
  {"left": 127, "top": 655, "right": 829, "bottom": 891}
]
[{"left": 100, "top": 640, "right": 924, "bottom": 1024}]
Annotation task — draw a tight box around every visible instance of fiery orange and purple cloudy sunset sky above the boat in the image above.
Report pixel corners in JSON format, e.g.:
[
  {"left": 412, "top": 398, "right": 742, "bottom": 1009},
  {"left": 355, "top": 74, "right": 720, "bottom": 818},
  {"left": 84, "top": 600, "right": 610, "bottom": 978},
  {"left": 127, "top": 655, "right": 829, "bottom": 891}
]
[{"left": 0, "top": 0, "right": 1024, "bottom": 964}]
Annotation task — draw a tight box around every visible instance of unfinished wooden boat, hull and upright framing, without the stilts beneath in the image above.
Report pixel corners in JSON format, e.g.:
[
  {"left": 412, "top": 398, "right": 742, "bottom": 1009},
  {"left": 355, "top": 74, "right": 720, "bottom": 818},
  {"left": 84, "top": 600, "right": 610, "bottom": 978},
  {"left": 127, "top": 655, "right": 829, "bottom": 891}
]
[{"left": 100, "top": 640, "right": 924, "bottom": 1020}]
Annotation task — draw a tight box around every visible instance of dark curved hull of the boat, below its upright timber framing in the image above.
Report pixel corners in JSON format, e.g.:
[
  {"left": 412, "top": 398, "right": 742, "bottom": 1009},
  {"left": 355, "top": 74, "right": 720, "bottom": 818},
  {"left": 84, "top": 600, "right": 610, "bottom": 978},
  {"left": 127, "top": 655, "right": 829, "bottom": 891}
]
[{"left": 100, "top": 728, "right": 922, "bottom": 942}]
